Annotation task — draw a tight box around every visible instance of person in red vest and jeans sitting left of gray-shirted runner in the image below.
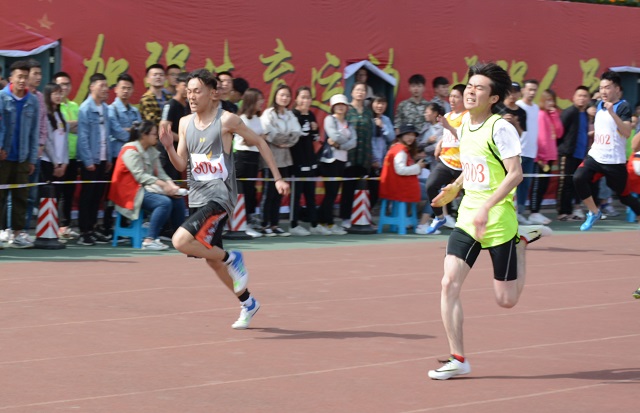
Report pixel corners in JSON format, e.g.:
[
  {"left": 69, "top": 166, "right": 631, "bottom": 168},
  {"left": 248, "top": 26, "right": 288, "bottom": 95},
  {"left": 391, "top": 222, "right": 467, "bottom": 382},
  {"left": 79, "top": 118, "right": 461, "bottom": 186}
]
[{"left": 109, "top": 120, "right": 185, "bottom": 251}]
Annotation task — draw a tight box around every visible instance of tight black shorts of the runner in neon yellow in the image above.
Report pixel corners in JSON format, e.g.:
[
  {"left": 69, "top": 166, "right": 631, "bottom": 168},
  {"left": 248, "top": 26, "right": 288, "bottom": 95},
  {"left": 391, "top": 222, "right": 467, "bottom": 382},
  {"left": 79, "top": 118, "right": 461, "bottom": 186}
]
[{"left": 446, "top": 228, "right": 520, "bottom": 281}]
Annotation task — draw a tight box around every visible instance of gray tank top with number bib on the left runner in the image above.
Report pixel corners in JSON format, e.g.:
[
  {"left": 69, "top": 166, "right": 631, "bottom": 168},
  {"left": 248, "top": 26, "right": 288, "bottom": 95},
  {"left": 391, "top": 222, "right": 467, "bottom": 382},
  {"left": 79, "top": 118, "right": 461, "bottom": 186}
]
[{"left": 185, "top": 106, "right": 238, "bottom": 215}]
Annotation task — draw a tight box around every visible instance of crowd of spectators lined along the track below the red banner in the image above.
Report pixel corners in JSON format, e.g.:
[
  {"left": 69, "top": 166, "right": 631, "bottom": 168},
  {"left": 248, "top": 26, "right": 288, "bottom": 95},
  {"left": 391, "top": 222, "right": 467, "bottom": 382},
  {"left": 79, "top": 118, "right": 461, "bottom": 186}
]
[{"left": 0, "top": 60, "right": 637, "bottom": 250}]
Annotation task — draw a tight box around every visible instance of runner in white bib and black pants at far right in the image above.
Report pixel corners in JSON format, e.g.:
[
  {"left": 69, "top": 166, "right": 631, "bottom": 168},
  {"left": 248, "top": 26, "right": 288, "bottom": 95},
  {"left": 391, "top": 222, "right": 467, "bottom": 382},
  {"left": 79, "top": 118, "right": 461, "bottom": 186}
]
[{"left": 573, "top": 72, "right": 640, "bottom": 231}]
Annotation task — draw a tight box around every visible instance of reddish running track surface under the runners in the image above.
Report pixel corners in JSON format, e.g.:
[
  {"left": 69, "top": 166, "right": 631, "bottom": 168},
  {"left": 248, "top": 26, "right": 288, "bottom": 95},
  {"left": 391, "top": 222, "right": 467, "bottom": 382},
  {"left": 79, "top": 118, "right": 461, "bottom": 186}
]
[{"left": 0, "top": 232, "right": 640, "bottom": 413}]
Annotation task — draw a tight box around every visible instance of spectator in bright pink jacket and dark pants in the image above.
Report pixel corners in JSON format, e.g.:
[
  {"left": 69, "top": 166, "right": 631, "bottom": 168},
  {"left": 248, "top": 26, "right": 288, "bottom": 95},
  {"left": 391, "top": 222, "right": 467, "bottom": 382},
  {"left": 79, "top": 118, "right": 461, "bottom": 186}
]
[{"left": 529, "top": 89, "right": 564, "bottom": 225}]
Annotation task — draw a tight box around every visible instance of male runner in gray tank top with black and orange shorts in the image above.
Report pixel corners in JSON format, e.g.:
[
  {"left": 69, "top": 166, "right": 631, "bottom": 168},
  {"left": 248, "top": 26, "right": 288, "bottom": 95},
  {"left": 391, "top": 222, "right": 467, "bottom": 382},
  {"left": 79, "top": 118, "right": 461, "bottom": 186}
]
[{"left": 160, "top": 69, "right": 289, "bottom": 329}]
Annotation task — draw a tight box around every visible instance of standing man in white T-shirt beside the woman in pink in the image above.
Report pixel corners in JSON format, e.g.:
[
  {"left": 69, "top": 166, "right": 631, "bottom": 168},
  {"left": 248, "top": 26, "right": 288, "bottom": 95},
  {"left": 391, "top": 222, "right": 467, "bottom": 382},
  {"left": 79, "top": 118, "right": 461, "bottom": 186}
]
[{"left": 516, "top": 79, "right": 540, "bottom": 224}]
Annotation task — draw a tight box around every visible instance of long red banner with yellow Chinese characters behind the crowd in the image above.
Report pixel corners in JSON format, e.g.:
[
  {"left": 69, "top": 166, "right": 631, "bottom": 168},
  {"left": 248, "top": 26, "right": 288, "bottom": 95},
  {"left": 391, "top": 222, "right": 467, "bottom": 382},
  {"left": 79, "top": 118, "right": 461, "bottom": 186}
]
[{"left": 0, "top": 0, "right": 640, "bottom": 111}]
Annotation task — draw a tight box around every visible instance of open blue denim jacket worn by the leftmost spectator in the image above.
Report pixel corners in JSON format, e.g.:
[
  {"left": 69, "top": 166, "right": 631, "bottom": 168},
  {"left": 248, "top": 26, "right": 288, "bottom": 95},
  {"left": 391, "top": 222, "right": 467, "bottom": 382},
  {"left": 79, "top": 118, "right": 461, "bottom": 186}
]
[{"left": 0, "top": 85, "right": 40, "bottom": 165}]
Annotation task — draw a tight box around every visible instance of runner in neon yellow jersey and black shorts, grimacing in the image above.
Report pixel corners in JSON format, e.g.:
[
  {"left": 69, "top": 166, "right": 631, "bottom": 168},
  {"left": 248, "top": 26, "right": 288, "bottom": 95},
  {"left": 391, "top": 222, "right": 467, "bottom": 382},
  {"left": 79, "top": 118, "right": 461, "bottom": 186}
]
[{"left": 429, "top": 63, "right": 551, "bottom": 380}]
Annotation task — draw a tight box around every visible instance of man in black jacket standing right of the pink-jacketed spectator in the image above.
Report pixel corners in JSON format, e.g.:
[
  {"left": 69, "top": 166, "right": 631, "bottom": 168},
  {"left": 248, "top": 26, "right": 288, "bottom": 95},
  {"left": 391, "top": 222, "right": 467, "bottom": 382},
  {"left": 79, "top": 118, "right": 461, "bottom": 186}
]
[{"left": 557, "top": 86, "right": 590, "bottom": 221}]
